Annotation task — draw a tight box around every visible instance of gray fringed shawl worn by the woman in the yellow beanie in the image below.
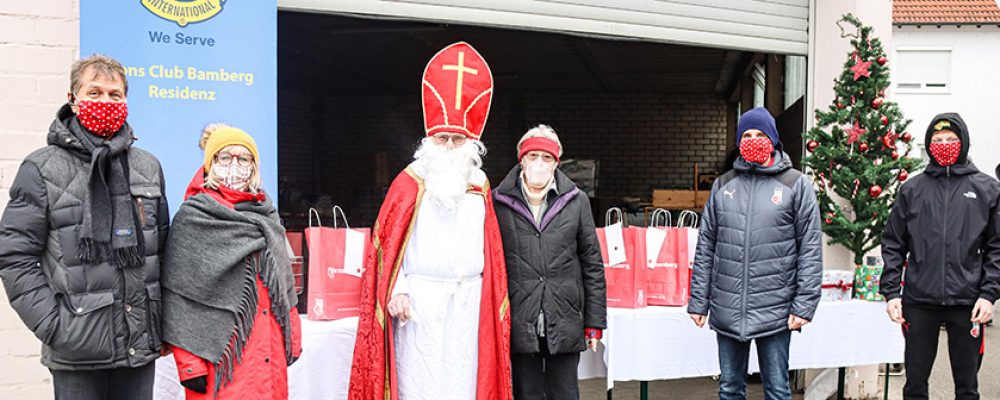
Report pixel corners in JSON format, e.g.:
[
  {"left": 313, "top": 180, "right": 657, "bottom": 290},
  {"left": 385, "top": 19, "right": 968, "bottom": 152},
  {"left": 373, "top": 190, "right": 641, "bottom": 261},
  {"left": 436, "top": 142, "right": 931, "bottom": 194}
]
[{"left": 160, "top": 194, "right": 297, "bottom": 393}]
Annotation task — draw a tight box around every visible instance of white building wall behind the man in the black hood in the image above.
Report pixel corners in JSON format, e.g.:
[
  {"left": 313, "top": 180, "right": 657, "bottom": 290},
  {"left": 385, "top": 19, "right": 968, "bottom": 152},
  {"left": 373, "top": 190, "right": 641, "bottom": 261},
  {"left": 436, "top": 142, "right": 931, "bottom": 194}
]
[{"left": 890, "top": 25, "right": 1000, "bottom": 176}]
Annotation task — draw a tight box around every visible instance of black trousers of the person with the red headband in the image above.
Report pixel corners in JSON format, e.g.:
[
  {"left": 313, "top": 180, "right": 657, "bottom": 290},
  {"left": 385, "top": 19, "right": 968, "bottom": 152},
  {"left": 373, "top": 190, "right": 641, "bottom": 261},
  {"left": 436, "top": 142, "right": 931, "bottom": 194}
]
[{"left": 510, "top": 338, "right": 580, "bottom": 400}]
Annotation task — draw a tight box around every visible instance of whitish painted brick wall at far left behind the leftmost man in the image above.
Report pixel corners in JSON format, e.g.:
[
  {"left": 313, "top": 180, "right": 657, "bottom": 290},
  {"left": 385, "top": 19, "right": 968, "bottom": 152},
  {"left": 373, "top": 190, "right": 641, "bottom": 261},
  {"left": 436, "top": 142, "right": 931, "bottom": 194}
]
[{"left": 0, "top": 0, "right": 80, "bottom": 400}]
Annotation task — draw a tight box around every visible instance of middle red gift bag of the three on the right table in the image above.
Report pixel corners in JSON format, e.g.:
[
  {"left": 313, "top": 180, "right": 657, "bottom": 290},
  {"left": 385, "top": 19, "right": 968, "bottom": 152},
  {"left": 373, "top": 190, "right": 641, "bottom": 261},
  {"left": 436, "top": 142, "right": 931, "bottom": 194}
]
[{"left": 636, "top": 209, "right": 691, "bottom": 306}]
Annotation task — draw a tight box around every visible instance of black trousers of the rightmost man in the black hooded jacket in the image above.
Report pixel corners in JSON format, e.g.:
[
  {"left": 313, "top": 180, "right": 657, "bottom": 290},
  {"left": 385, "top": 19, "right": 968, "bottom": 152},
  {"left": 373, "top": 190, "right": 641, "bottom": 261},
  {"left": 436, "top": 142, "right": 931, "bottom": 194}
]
[{"left": 903, "top": 304, "right": 986, "bottom": 400}]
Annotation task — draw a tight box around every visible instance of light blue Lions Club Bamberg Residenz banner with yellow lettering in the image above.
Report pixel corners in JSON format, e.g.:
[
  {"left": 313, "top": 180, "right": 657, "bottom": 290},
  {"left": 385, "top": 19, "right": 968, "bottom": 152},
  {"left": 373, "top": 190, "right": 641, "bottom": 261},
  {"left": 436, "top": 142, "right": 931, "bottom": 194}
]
[{"left": 80, "top": 0, "right": 278, "bottom": 212}]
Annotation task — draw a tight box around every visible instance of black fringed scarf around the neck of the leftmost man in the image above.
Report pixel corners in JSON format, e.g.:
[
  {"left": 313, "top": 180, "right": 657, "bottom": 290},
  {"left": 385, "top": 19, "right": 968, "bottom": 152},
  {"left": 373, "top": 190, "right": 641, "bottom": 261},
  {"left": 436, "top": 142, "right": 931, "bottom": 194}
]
[{"left": 68, "top": 117, "right": 145, "bottom": 268}]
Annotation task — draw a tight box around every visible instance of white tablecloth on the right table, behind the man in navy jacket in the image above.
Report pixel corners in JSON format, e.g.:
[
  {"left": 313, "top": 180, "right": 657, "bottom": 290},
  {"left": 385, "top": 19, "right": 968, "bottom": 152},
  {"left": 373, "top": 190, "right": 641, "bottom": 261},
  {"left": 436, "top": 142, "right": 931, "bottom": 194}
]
[{"left": 579, "top": 300, "right": 903, "bottom": 388}]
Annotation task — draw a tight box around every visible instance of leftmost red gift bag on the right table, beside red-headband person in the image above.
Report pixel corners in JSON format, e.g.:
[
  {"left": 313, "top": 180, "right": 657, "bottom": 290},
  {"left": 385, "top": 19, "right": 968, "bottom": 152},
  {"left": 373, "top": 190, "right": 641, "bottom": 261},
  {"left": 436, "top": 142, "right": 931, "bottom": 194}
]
[{"left": 597, "top": 208, "right": 646, "bottom": 308}]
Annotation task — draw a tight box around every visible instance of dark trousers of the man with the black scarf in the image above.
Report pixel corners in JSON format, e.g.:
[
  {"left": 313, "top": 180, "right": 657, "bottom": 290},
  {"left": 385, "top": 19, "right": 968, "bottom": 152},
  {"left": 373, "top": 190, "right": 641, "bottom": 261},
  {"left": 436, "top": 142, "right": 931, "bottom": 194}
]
[{"left": 49, "top": 362, "right": 156, "bottom": 400}]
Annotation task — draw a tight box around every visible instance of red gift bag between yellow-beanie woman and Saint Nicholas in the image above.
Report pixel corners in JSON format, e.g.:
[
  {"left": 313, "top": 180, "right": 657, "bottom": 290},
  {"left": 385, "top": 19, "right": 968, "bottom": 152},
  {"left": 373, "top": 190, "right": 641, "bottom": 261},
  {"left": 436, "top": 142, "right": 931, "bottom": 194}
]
[{"left": 305, "top": 207, "right": 371, "bottom": 320}]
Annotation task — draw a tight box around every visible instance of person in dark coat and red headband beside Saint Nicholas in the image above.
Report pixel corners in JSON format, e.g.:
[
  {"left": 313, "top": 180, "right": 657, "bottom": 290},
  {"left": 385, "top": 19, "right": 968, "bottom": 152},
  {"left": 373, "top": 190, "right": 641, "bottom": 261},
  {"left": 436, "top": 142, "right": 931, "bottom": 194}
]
[{"left": 493, "top": 125, "right": 607, "bottom": 400}]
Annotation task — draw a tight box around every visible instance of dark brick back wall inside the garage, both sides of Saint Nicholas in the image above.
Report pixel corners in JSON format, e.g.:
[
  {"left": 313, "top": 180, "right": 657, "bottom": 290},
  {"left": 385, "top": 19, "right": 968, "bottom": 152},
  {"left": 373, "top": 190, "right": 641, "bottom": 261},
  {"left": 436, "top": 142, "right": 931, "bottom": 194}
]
[{"left": 279, "top": 94, "right": 730, "bottom": 226}]
